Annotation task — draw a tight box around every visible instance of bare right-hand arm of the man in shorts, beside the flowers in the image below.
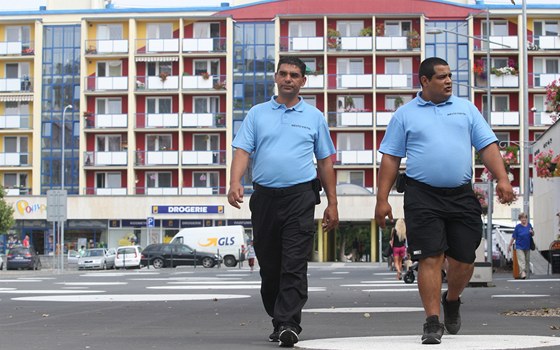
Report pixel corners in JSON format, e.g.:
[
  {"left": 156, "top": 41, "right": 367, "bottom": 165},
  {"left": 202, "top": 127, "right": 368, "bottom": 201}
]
[{"left": 479, "top": 143, "right": 514, "bottom": 204}]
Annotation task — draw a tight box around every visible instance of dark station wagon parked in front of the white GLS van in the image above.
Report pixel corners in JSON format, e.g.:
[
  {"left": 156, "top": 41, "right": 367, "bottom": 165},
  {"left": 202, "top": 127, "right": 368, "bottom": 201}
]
[{"left": 140, "top": 243, "right": 221, "bottom": 269}]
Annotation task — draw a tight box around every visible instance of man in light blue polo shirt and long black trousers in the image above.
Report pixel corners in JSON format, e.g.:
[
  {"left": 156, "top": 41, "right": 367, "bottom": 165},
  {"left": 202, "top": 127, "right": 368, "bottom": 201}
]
[{"left": 228, "top": 56, "right": 338, "bottom": 347}]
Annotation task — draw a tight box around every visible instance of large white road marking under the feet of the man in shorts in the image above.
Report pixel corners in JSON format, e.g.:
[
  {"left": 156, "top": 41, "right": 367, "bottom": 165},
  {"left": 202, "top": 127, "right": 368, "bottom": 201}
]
[{"left": 297, "top": 334, "right": 560, "bottom": 350}]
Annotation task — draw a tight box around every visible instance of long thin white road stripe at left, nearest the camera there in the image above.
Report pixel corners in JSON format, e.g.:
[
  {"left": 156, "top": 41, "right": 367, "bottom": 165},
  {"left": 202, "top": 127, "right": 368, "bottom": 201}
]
[{"left": 12, "top": 294, "right": 251, "bottom": 302}]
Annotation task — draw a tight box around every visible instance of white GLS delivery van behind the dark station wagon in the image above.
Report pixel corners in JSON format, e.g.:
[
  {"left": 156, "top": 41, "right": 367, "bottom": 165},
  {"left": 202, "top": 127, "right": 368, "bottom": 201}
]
[{"left": 171, "top": 226, "right": 249, "bottom": 267}]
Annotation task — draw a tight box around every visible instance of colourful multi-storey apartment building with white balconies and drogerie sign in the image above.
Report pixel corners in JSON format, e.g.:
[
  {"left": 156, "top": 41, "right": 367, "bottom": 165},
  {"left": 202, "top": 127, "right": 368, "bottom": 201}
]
[{"left": 0, "top": 0, "right": 560, "bottom": 261}]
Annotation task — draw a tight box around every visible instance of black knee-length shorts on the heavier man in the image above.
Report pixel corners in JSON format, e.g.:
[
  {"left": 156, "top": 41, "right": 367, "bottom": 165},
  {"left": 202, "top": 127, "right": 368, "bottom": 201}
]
[{"left": 404, "top": 180, "right": 483, "bottom": 264}]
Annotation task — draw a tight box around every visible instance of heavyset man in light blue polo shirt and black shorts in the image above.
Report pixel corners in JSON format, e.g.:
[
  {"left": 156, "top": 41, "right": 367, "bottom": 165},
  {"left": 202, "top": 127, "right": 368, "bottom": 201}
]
[{"left": 375, "top": 57, "right": 514, "bottom": 344}]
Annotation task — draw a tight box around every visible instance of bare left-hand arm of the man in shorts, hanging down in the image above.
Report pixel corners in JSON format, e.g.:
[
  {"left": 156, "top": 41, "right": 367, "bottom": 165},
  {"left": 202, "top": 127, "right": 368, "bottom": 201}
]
[{"left": 375, "top": 154, "right": 401, "bottom": 228}]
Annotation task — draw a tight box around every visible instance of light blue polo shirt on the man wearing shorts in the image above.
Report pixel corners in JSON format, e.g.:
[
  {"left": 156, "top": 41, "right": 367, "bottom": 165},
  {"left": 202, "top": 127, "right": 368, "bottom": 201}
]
[{"left": 379, "top": 92, "right": 498, "bottom": 187}]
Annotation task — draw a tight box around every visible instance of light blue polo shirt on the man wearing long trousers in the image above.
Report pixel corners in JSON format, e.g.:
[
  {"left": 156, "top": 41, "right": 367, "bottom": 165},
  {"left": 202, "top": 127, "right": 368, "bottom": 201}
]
[{"left": 232, "top": 96, "right": 336, "bottom": 188}]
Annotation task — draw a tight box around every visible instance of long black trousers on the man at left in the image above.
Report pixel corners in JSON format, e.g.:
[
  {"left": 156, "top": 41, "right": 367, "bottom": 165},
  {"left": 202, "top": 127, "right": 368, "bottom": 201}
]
[{"left": 249, "top": 189, "right": 315, "bottom": 333}]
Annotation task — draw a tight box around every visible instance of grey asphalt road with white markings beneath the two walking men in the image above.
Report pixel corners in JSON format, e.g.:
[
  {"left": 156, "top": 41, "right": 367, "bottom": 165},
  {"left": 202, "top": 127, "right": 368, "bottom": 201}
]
[{"left": 0, "top": 263, "right": 560, "bottom": 350}]
